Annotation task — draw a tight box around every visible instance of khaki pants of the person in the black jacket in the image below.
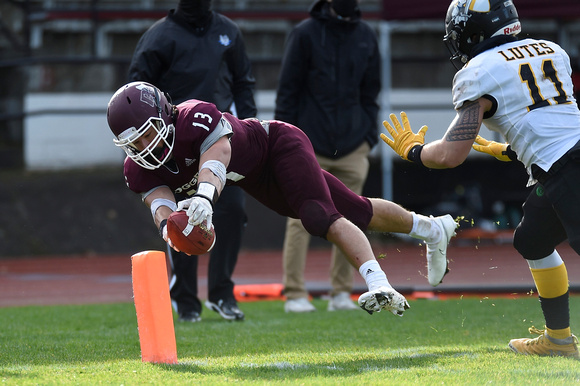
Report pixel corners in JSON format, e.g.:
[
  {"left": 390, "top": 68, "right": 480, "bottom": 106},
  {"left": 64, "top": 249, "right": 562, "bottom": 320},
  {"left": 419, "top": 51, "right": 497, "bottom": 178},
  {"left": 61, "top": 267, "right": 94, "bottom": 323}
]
[{"left": 282, "top": 142, "right": 370, "bottom": 299}]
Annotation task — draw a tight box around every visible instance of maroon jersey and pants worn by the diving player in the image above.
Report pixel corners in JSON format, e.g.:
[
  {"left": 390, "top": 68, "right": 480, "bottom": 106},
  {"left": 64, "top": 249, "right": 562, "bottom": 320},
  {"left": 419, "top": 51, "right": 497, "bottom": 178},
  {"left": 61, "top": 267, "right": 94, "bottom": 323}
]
[{"left": 124, "top": 100, "right": 372, "bottom": 234}]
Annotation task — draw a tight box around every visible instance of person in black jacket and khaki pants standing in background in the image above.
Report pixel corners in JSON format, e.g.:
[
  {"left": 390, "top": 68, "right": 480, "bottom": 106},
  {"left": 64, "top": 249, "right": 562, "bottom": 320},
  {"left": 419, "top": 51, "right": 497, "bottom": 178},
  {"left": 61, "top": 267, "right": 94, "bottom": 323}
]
[{"left": 274, "top": 0, "right": 381, "bottom": 312}]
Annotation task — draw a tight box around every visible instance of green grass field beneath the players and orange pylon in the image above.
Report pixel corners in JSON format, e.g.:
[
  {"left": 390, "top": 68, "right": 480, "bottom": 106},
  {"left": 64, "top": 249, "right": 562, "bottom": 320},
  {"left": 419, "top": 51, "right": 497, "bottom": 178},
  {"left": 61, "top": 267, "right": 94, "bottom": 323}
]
[{"left": 0, "top": 296, "right": 580, "bottom": 385}]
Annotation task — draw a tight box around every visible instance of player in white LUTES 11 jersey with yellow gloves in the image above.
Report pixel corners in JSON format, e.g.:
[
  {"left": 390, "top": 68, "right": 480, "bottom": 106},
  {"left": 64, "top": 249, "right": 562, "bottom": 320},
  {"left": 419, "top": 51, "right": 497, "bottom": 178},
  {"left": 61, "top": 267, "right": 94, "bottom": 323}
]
[{"left": 381, "top": 0, "right": 580, "bottom": 358}]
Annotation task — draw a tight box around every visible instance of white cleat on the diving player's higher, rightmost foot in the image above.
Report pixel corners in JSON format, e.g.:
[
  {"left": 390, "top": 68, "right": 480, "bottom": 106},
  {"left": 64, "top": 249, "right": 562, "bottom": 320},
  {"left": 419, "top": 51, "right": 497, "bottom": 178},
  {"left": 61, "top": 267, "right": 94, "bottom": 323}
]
[{"left": 425, "top": 214, "right": 459, "bottom": 287}]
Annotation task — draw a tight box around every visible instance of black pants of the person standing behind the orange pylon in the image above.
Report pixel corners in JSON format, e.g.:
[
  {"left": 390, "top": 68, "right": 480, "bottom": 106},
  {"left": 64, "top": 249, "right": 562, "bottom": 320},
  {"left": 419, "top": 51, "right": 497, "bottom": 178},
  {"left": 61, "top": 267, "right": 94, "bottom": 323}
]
[{"left": 168, "top": 186, "right": 247, "bottom": 314}]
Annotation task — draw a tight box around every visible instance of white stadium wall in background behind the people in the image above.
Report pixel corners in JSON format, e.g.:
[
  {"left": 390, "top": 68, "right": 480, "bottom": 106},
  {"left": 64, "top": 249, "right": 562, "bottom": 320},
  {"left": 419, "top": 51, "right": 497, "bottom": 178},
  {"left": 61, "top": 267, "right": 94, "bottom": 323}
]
[{"left": 24, "top": 89, "right": 497, "bottom": 170}]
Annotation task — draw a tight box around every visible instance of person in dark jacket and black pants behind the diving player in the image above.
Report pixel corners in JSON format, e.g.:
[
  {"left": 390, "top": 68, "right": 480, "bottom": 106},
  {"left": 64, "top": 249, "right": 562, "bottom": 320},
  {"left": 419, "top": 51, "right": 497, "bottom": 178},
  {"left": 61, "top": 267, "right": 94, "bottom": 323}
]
[{"left": 129, "top": 0, "right": 257, "bottom": 322}]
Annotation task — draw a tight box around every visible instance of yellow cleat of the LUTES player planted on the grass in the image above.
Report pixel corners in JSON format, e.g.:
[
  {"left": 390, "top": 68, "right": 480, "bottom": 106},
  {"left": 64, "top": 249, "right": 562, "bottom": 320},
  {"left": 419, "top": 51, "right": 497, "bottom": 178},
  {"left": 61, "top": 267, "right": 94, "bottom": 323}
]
[{"left": 508, "top": 326, "right": 580, "bottom": 359}]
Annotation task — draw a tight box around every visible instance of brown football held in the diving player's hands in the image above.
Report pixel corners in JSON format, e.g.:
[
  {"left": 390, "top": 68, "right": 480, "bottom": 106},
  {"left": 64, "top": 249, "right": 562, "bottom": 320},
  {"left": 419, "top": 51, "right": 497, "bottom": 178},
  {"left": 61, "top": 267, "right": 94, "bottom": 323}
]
[{"left": 167, "top": 211, "right": 215, "bottom": 255}]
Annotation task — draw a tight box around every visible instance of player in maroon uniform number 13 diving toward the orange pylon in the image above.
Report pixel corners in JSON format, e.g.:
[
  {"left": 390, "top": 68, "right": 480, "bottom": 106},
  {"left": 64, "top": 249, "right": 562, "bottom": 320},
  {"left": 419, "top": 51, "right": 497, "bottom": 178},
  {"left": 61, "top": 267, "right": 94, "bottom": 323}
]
[{"left": 107, "top": 82, "right": 457, "bottom": 315}]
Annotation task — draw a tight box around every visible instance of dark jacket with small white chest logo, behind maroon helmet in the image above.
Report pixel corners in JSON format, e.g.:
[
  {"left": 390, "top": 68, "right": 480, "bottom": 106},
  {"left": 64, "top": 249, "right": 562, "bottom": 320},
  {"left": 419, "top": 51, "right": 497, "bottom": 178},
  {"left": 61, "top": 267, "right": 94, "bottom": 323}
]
[{"left": 129, "top": 10, "right": 257, "bottom": 119}]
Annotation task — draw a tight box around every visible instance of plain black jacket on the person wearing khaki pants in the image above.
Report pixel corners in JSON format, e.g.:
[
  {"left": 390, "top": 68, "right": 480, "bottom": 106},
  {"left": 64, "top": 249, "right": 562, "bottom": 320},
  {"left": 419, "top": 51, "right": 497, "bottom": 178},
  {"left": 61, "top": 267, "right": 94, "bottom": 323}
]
[{"left": 275, "top": 0, "right": 381, "bottom": 158}]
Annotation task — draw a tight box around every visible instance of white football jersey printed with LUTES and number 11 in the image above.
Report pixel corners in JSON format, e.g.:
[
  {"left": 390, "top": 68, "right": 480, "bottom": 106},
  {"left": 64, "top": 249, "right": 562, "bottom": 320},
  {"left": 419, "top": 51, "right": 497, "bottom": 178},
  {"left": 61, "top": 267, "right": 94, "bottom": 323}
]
[{"left": 453, "top": 39, "right": 580, "bottom": 182}]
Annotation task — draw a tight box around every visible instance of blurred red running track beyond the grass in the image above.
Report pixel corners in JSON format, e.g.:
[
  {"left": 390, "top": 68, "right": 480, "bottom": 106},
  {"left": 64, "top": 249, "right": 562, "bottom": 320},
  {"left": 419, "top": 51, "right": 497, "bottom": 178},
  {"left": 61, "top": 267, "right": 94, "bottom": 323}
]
[{"left": 0, "top": 240, "right": 580, "bottom": 307}]
